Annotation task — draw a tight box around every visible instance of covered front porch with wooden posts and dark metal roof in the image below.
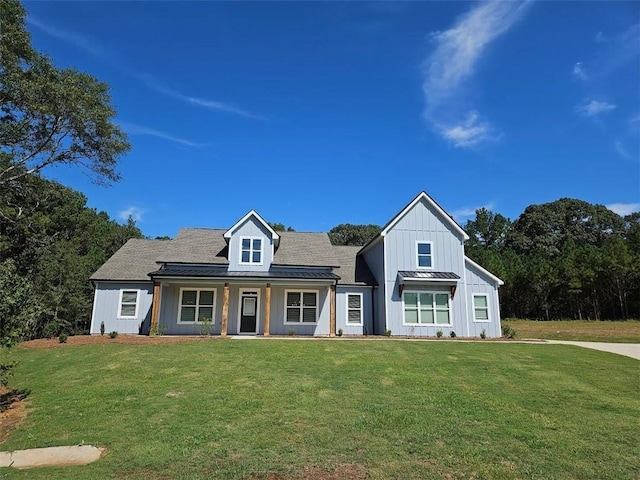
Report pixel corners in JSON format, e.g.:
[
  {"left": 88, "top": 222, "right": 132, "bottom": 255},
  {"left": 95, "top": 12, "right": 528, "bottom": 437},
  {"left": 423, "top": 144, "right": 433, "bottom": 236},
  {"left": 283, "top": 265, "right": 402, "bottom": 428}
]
[{"left": 150, "top": 266, "right": 339, "bottom": 337}]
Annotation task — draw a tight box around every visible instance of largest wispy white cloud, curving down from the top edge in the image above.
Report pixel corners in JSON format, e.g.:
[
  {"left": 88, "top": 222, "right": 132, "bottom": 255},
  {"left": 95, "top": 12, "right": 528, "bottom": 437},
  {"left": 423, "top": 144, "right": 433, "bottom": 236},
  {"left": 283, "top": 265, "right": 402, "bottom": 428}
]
[{"left": 422, "top": 1, "right": 530, "bottom": 147}]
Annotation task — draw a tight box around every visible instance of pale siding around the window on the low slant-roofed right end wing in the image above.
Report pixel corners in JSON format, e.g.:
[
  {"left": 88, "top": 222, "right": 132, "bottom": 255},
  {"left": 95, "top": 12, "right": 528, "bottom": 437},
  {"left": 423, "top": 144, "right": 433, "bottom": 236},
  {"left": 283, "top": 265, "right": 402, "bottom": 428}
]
[{"left": 465, "top": 262, "right": 502, "bottom": 338}]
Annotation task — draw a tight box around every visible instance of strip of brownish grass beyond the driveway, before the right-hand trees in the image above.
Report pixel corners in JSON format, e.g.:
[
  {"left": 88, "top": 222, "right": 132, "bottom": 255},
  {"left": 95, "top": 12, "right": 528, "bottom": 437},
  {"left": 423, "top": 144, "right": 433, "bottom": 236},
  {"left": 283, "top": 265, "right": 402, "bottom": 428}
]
[{"left": 502, "top": 319, "right": 640, "bottom": 343}]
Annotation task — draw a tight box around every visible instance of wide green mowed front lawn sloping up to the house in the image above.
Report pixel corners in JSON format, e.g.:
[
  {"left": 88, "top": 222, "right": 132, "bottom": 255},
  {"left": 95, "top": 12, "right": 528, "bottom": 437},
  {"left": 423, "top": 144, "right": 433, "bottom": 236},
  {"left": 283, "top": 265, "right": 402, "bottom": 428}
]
[{"left": 0, "top": 339, "right": 640, "bottom": 480}]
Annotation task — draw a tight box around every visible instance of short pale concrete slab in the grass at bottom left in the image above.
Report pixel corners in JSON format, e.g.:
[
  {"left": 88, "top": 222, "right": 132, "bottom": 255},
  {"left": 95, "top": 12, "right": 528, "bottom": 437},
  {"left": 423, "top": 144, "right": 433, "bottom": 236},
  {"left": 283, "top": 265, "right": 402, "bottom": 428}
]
[{"left": 0, "top": 445, "right": 102, "bottom": 468}]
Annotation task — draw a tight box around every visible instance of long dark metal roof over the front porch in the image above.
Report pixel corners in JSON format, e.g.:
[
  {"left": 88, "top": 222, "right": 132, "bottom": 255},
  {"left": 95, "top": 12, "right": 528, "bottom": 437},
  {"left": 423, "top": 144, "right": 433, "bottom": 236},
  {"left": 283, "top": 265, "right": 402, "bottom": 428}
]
[{"left": 149, "top": 266, "right": 340, "bottom": 281}]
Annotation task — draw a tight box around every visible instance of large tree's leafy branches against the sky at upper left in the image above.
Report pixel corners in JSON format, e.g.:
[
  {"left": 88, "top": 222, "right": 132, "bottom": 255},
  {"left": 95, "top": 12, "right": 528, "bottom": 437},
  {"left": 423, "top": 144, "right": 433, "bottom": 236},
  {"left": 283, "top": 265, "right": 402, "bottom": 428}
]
[{"left": 0, "top": 0, "right": 130, "bottom": 197}]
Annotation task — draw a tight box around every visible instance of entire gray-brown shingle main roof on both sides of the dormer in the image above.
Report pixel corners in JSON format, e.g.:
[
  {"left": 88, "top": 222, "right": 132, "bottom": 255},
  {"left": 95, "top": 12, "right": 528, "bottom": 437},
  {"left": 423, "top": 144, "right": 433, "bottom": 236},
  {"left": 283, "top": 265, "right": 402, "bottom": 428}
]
[{"left": 91, "top": 228, "right": 376, "bottom": 285}]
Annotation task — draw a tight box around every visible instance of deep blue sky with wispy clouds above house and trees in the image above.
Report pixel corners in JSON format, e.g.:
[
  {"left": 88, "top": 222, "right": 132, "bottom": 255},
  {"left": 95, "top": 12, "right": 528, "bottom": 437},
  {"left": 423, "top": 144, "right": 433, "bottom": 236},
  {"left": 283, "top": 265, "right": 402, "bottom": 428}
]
[{"left": 25, "top": 1, "right": 640, "bottom": 237}]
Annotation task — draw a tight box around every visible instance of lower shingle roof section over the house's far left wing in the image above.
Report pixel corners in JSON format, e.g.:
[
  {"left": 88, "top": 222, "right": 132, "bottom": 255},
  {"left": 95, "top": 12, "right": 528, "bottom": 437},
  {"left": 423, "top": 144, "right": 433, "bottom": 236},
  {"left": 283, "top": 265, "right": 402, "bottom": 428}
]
[{"left": 90, "top": 239, "right": 172, "bottom": 281}]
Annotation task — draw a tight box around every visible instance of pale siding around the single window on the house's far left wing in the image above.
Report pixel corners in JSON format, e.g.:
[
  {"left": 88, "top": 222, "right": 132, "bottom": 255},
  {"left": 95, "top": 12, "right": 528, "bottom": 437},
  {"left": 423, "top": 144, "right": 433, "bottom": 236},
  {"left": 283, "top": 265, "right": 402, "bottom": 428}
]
[{"left": 90, "top": 282, "right": 153, "bottom": 335}]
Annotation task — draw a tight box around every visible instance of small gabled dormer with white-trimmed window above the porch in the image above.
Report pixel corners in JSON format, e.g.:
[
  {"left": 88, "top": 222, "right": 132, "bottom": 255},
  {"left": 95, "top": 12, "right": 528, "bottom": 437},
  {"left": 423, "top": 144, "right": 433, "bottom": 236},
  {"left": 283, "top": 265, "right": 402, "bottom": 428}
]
[{"left": 224, "top": 210, "right": 280, "bottom": 272}]
